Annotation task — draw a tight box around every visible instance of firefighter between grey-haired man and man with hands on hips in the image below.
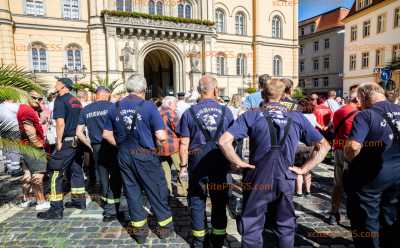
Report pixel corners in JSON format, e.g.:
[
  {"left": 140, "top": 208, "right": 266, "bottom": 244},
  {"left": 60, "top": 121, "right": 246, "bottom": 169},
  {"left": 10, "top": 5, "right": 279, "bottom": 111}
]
[{"left": 177, "top": 76, "right": 233, "bottom": 247}]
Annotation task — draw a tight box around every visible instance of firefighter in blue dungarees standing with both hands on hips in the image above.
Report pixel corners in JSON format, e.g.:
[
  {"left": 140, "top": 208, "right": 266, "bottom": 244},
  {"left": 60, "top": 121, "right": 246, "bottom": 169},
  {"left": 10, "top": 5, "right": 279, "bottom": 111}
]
[{"left": 219, "top": 79, "right": 330, "bottom": 248}]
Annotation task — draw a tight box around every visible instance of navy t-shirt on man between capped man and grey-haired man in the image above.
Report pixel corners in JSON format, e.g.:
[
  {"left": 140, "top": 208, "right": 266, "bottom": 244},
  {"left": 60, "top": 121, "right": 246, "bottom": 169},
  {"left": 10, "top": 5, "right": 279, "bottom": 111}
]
[{"left": 79, "top": 101, "right": 114, "bottom": 144}]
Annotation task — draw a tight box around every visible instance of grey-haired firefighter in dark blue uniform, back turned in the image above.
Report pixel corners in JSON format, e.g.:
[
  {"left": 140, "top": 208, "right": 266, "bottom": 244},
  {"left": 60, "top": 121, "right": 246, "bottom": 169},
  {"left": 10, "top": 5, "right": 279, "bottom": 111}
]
[{"left": 103, "top": 75, "right": 173, "bottom": 243}]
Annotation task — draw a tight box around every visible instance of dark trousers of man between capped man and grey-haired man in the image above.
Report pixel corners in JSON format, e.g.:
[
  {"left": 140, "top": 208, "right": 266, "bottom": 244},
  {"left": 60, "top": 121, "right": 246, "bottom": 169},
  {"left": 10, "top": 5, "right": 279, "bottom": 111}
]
[{"left": 93, "top": 141, "right": 122, "bottom": 216}]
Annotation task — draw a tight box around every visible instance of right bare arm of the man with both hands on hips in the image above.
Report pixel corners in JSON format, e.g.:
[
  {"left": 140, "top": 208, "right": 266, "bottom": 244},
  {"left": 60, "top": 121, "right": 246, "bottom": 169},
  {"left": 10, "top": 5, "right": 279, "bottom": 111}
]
[{"left": 289, "top": 139, "right": 331, "bottom": 175}]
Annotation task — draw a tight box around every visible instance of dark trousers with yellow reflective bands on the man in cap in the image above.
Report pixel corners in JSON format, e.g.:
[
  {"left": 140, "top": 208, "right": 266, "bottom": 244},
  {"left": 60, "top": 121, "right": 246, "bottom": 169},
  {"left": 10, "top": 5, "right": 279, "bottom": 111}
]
[{"left": 48, "top": 141, "right": 86, "bottom": 212}]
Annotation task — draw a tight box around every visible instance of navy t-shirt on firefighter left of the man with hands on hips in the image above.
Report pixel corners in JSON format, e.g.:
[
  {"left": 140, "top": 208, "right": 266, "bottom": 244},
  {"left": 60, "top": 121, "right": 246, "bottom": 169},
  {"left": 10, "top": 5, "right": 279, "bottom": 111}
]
[{"left": 177, "top": 99, "right": 234, "bottom": 149}]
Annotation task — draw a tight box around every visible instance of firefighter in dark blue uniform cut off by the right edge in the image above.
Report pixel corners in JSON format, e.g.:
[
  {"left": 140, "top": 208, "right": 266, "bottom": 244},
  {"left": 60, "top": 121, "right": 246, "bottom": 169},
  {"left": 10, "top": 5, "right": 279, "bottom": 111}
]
[{"left": 344, "top": 83, "right": 400, "bottom": 248}]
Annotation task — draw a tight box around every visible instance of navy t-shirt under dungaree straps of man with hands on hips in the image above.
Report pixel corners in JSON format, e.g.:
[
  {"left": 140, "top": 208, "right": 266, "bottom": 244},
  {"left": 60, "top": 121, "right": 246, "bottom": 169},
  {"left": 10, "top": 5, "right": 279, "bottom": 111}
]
[{"left": 228, "top": 103, "right": 323, "bottom": 164}]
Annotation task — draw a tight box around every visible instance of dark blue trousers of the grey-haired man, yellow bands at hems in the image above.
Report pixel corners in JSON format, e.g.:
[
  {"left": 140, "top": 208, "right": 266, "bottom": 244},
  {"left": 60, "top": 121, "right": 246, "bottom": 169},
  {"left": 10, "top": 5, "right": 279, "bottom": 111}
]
[{"left": 118, "top": 147, "right": 172, "bottom": 228}]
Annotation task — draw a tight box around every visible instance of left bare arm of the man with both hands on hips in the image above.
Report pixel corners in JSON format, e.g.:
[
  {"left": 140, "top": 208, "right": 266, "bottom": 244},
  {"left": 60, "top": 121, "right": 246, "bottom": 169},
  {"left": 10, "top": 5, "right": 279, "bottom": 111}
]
[{"left": 219, "top": 132, "right": 255, "bottom": 169}]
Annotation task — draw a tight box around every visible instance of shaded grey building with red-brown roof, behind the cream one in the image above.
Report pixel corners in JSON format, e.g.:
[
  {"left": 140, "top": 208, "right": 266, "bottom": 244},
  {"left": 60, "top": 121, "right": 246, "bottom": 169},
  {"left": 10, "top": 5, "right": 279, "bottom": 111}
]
[{"left": 299, "top": 7, "right": 349, "bottom": 95}]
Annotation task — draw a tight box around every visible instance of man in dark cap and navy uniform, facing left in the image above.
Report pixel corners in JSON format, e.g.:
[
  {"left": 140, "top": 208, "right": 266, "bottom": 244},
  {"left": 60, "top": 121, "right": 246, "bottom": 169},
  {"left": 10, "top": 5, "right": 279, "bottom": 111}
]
[{"left": 37, "top": 78, "right": 86, "bottom": 219}]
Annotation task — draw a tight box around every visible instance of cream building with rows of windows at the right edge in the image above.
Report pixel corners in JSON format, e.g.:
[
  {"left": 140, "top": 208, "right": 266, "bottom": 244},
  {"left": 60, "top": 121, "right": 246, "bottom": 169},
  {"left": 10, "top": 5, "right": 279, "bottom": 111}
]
[{"left": 343, "top": 0, "right": 400, "bottom": 94}]
